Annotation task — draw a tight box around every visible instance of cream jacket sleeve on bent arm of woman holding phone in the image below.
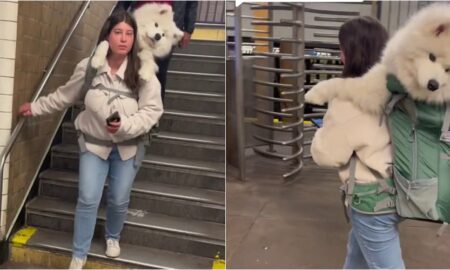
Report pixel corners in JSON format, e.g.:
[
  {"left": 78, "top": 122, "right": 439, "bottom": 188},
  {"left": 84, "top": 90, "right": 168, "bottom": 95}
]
[{"left": 115, "top": 76, "right": 163, "bottom": 140}]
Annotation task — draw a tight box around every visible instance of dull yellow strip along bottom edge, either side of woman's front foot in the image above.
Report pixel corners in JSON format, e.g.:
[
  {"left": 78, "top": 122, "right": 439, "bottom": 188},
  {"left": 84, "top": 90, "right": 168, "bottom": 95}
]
[{"left": 10, "top": 245, "right": 125, "bottom": 269}]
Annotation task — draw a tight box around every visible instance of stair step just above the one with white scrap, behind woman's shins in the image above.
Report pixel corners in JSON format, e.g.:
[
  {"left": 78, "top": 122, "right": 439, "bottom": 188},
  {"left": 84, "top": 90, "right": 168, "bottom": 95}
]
[{"left": 39, "top": 167, "right": 225, "bottom": 223}]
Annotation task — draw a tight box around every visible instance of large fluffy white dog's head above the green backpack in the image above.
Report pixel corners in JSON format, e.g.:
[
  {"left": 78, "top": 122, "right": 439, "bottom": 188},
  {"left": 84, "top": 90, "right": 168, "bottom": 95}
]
[{"left": 383, "top": 4, "right": 450, "bottom": 103}]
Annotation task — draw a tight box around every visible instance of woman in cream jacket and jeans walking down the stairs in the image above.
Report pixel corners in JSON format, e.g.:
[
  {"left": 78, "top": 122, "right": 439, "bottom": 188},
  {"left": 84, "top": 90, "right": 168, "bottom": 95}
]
[{"left": 20, "top": 11, "right": 163, "bottom": 269}]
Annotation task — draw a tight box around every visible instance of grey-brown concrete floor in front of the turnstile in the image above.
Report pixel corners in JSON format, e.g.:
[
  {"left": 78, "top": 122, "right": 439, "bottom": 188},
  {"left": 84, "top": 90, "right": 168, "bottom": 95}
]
[{"left": 226, "top": 154, "right": 450, "bottom": 269}]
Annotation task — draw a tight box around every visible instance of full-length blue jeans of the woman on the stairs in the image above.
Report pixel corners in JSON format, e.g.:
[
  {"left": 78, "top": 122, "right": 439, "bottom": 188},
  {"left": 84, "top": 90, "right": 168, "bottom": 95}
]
[{"left": 73, "top": 146, "right": 139, "bottom": 258}]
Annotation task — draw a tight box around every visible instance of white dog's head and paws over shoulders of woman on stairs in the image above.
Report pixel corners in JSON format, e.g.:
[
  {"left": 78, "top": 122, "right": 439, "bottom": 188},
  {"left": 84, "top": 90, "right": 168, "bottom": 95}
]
[{"left": 91, "top": 3, "right": 183, "bottom": 81}]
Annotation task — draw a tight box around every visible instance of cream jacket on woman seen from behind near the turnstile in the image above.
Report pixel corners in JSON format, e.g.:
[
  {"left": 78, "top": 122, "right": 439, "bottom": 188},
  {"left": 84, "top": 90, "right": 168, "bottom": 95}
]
[{"left": 311, "top": 99, "right": 392, "bottom": 184}]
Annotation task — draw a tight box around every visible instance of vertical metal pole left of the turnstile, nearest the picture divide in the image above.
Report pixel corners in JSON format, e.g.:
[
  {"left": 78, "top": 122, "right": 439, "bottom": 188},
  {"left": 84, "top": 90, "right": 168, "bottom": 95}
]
[{"left": 234, "top": 5, "right": 246, "bottom": 181}]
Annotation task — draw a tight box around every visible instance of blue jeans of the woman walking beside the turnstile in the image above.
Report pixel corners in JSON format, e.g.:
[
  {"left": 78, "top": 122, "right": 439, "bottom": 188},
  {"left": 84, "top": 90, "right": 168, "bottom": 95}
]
[{"left": 344, "top": 209, "right": 405, "bottom": 269}]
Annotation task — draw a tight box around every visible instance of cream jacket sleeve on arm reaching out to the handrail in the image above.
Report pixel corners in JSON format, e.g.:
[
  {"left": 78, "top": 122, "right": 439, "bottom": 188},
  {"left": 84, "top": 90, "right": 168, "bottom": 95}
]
[{"left": 31, "top": 58, "right": 89, "bottom": 116}]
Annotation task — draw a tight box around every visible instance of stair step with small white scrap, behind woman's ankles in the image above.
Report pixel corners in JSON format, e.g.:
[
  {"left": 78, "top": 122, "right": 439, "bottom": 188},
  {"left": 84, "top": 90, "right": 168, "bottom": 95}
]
[{"left": 26, "top": 197, "right": 225, "bottom": 257}]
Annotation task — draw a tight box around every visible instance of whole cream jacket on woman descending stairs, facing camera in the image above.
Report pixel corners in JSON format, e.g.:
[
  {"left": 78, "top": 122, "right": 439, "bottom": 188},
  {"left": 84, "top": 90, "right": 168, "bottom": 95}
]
[{"left": 31, "top": 58, "right": 163, "bottom": 160}]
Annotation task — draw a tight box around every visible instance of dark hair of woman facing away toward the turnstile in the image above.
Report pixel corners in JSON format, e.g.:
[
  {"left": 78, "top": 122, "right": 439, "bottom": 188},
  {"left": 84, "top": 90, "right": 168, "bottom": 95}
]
[{"left": 339, "top": 16, "right": 389, "bottom": 78}]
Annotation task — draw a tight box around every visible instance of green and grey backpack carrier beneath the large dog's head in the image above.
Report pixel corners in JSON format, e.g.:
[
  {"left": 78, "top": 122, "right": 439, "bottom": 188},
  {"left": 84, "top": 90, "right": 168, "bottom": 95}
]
[{"left": 386, "top": 75, "right": 450, "bottom": 230}]
